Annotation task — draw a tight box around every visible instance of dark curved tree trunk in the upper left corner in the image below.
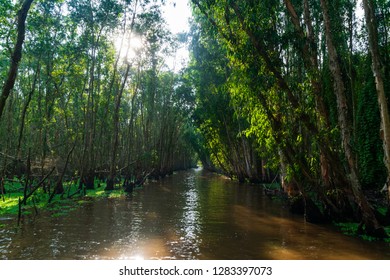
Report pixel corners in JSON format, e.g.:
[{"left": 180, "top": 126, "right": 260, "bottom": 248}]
[{"left": 0, "top": 0, "right": 33, "bottom": 119}]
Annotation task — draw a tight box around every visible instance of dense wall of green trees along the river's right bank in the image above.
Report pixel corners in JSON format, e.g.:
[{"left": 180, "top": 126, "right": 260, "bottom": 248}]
[{"left": 185, "top": 0, "right": 390, "bottom": 236}]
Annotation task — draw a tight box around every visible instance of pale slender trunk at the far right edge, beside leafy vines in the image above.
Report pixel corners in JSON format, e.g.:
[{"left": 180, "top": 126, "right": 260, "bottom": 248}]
[{"left": 363, "top": 0, "right": 390, "bottom": 202}]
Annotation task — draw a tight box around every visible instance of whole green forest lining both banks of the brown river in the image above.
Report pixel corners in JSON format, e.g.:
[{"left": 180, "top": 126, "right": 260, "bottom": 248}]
[{"left": 0, "top": 0, "right": 390, "bottom": 241}]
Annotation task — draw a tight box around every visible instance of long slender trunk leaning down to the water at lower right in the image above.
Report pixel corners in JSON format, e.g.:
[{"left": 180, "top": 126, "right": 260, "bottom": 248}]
[{"left": 321, "top": 0, "right": 386, "bottom": 236}]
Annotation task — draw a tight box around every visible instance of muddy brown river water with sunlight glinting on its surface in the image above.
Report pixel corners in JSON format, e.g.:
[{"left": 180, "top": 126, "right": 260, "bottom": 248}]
[{"left": 0, "top": 167, "right": 390, "bottom": 259}]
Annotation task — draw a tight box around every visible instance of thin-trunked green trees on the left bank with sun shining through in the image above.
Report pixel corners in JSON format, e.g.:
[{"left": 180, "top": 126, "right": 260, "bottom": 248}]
[{"left": 0, "top": 0, "right": 194, "bottom": 197}]
